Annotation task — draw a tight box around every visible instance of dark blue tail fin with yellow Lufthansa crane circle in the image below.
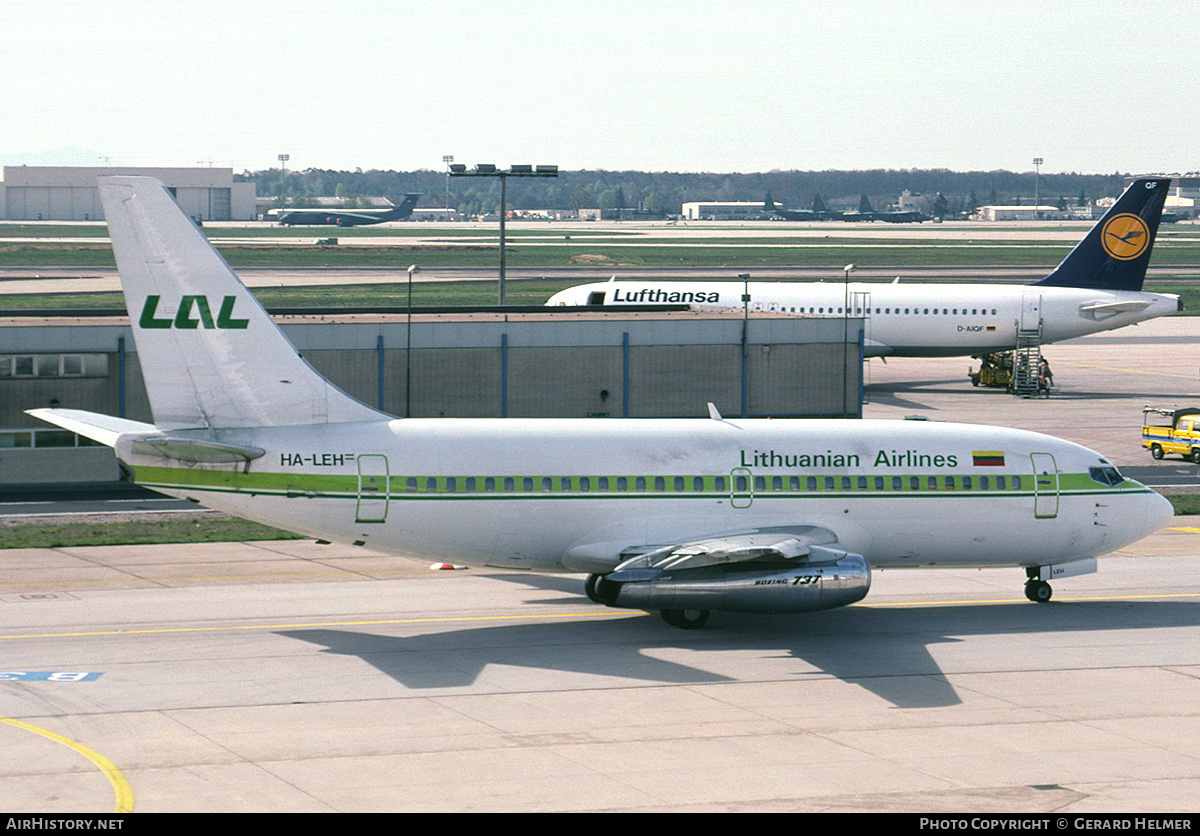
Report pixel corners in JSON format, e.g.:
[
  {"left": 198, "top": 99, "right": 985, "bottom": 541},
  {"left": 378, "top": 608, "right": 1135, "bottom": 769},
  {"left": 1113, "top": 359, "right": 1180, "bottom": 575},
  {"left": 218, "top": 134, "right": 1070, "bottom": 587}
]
[{"left": 1033, "top": 178, "right": 1171, "bottom": 290}]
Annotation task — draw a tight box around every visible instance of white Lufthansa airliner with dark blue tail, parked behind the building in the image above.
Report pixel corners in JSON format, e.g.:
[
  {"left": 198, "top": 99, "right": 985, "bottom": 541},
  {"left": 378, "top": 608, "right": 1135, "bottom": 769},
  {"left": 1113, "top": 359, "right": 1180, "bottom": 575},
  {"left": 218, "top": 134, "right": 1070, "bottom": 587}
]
[{"left": 546, "top": 178, "right": 1182, "bottom": 357}]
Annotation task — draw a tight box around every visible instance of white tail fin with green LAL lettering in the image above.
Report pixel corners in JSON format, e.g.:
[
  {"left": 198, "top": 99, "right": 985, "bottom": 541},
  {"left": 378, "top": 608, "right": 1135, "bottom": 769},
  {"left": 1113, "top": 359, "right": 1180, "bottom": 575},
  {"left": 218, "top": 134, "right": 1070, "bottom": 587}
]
[{"left": 97, "top": 176, "right": 388, "bottom": 431}]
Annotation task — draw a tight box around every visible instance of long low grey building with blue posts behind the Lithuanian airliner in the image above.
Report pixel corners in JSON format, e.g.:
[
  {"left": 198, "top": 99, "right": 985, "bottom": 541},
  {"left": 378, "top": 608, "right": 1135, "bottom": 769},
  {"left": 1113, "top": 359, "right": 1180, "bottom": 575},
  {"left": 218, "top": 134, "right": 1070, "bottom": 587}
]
[{"left": 0, "top": 309, "right": 863, "bottom": 486}]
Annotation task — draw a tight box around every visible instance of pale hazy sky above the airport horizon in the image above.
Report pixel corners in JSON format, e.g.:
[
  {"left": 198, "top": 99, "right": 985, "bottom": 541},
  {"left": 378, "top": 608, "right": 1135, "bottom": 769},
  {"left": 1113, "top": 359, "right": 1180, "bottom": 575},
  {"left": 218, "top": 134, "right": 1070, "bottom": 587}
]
[{"left": 0, "top": 0, "right": 1200, "bottom": 173}]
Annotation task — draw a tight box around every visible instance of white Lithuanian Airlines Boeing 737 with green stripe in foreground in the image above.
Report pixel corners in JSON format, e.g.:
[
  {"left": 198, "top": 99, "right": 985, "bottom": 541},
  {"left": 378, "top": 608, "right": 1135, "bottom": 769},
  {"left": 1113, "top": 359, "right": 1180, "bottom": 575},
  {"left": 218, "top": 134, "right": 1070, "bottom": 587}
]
[{"left": 30, "top": 178, "right": 1172, "bottom": 627}]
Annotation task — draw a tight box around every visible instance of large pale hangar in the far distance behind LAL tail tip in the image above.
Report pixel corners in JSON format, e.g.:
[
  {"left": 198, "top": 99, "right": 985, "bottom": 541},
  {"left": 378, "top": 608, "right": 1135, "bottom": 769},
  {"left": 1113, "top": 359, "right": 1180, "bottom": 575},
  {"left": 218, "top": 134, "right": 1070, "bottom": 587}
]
[{"left": 0, "top": 166, "right": 256, "bottom": 221}]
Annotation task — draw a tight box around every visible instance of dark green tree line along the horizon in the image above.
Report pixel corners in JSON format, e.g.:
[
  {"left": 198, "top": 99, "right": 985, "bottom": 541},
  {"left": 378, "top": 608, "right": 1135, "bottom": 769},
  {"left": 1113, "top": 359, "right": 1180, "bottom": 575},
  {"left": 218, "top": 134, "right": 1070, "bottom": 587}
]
[{"left": 239, "top": 168, "right": 1127, "bottom": 215}]
